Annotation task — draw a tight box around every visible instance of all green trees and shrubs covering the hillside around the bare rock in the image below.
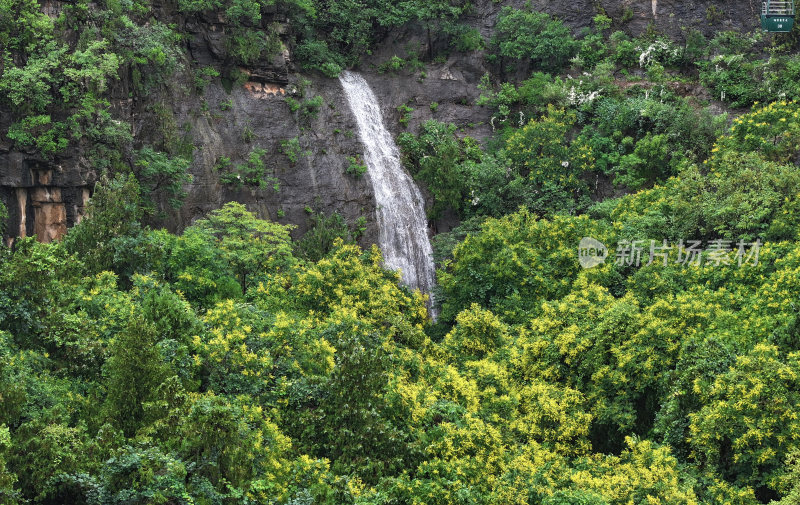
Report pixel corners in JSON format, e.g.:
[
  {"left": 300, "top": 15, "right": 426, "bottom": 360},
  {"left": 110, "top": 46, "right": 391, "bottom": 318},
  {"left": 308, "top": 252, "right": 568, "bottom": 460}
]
[{"left": 0, "top": 0, "right": 800, "bottom": 505}]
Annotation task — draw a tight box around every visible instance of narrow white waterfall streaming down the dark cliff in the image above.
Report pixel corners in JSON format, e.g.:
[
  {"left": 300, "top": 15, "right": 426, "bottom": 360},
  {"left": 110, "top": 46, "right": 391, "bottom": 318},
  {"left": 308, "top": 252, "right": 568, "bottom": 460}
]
[{"left": 339, "top": 71, "right": 436, "bottom": 319}]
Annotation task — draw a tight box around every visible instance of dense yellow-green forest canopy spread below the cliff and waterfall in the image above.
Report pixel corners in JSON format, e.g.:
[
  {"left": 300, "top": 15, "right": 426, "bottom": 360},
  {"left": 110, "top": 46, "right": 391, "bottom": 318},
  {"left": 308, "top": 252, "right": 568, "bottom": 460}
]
[{"left": 0, "top": 102, "right": 800, "bottom": 504}]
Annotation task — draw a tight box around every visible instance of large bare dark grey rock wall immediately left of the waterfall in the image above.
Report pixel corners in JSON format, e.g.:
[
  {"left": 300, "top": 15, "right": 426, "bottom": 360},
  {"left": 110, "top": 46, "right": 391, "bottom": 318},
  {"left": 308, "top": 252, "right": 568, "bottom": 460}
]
[{"left": 147, "top": 70, "right": 384, "bottom": 241}]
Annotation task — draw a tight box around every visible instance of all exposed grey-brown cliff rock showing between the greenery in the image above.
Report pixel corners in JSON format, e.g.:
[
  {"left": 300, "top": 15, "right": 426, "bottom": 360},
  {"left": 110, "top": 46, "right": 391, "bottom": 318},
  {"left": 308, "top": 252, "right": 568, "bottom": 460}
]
[{"left": 0, "top": 0, "right": 758, "bottom": 245}]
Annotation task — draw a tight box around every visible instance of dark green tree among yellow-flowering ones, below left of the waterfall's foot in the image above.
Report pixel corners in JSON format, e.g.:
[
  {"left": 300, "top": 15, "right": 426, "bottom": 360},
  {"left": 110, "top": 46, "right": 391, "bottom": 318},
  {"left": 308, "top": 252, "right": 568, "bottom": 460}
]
[{"left": 290, "top": 316, "right": 412, "bottom": 483}]
